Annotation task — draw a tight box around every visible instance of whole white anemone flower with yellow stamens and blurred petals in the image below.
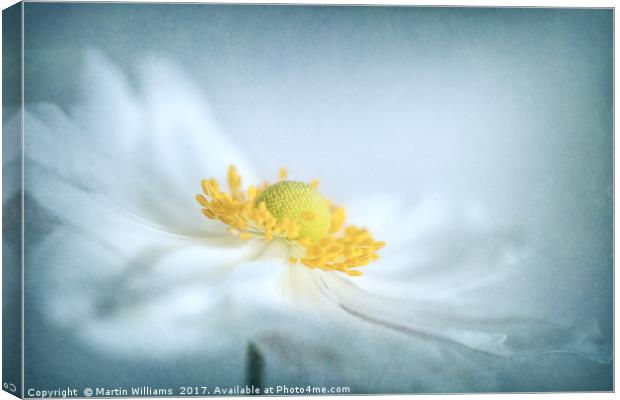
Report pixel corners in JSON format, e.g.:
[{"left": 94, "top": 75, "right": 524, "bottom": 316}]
[{"left": 14, "top": 52, "right": 609, "bottom": 393}]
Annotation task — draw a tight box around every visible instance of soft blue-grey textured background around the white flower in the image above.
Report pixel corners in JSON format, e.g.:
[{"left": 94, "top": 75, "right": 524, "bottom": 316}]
[{"left": 25, "top": 3, "right": 613, "bottom": 391}]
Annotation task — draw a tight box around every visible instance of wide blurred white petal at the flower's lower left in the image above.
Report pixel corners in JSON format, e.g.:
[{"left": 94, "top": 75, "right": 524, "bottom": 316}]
[{"left": 27, "top": 222, "right": 264, "bottom": 357}]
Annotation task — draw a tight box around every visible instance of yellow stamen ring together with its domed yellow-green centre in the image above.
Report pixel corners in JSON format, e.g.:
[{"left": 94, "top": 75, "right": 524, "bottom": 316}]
[{"left": 196, "top": 166, "right": 385, "bottom": 276}]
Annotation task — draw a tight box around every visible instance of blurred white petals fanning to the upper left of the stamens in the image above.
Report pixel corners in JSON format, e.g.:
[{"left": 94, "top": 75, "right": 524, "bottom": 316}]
[{"left": 25, "top": 52, "right": 253, "bottom": 235}]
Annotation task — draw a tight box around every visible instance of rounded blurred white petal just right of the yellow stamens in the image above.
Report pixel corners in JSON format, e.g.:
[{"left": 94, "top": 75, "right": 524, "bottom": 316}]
[{"left": 352, "top": 192, "right": 531, "bottom": 301}]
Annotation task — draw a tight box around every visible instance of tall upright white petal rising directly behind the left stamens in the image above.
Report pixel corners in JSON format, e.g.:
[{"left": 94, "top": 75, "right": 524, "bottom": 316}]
[{"left": 126, "top": 55, "right": 259, "bottom": 233}]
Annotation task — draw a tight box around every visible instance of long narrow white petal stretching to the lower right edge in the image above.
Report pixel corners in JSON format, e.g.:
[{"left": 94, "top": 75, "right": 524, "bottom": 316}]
[{"left": 320, "top": 275, "right": 611, "bottom": 363}]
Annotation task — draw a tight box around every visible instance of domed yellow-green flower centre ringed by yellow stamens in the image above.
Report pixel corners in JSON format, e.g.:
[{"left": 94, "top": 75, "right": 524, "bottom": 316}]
[{"left": 255, "top": 181, "right": 332, "bottom": 241}]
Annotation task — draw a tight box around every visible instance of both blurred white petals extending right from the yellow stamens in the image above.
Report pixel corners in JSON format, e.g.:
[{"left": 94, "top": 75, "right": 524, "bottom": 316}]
[{"left": 340, "top": 196, "right": 611, "bottom": 363}]
